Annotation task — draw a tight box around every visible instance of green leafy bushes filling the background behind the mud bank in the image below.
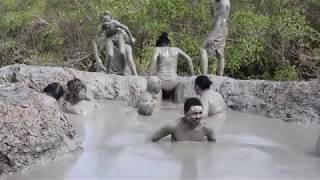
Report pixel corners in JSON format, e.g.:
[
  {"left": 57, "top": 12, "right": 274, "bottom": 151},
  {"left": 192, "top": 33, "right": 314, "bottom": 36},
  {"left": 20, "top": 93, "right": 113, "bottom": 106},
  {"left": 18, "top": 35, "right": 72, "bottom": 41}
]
[{"left": 0, "top": 0, "right": 320, "bottom": 80}]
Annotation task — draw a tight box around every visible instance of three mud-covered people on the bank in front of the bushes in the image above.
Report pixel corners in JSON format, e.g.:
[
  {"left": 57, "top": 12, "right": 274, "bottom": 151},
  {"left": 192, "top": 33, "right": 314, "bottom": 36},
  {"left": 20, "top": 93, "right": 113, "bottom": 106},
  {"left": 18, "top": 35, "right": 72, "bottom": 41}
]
[{"left": 93, "top": 0, "right": 230, "bottom": 101}]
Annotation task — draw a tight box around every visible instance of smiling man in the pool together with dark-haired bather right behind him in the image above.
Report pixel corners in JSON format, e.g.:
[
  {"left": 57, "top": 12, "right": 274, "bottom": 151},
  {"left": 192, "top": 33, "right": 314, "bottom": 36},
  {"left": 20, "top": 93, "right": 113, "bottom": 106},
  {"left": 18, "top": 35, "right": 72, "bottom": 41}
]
[{"left": 151, "top": 75, "right": 226, "bottom": 142}]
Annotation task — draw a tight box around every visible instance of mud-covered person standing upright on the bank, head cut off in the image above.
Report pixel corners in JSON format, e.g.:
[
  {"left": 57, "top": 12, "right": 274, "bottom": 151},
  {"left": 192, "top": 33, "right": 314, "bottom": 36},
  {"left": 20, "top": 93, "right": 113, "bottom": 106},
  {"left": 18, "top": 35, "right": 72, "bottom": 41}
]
[{"left": 200, "top": 0, "right": 230, "bottom": 76}]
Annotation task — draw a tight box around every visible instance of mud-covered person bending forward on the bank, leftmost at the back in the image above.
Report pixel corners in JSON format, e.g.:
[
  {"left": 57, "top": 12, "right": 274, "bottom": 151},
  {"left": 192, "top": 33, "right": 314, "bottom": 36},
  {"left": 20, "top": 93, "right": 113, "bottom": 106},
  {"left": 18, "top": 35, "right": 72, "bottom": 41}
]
[{"left": 93, "top": 11, "right": 138, "bottom": 75}]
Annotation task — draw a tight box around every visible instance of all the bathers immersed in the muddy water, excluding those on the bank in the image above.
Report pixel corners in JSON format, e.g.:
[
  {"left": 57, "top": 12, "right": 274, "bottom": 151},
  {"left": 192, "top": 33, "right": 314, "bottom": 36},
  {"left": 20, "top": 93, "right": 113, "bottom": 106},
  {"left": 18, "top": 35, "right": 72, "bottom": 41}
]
[{"left": 43, "top": 75, "right": 226, "bottom": 142}]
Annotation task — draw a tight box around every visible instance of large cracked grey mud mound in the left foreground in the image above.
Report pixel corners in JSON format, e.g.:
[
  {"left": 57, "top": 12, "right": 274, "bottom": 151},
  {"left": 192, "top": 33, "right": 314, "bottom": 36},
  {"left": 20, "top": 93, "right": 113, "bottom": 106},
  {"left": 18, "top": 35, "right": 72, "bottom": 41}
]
[{"left": 0, "top": 83, "right": 81, "bottom": 175}]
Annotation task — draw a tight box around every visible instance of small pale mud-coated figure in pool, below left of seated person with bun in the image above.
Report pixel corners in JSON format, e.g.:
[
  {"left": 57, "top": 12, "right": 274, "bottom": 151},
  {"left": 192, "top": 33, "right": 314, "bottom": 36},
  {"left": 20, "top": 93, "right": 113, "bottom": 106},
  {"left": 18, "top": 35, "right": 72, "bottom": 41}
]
[{"left": 138, "top": 76, "right": 161, "bottom": 116}]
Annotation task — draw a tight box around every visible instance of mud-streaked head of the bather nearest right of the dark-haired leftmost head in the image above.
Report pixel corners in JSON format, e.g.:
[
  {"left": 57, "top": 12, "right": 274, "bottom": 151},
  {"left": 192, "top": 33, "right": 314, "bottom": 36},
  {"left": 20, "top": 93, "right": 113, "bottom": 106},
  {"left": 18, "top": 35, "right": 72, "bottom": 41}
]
[{"left": 67, "top": 78, "right": 87, "bottom": 100}]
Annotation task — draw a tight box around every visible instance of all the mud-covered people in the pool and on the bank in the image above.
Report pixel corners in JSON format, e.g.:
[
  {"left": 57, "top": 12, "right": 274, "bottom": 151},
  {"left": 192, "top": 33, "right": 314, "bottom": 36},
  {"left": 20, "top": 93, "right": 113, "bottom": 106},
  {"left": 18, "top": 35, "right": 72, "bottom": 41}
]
[{"left": 43, "top": 0, "right": 230, "bottom": 141}]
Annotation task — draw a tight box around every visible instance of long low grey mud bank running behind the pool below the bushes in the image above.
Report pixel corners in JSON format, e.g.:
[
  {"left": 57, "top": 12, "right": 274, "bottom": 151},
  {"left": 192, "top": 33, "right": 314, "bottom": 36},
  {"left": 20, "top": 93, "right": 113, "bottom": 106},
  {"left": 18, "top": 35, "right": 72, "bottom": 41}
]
[{"left": 0, "top": 65, "right": 320, "bottom": 124}]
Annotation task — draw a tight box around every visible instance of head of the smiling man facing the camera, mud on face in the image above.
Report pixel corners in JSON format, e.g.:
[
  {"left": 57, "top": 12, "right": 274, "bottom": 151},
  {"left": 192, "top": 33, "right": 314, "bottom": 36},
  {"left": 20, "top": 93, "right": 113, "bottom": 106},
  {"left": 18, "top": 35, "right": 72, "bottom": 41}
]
[{"left": 183, "top": 98, "right": 202, "bottom": 127}]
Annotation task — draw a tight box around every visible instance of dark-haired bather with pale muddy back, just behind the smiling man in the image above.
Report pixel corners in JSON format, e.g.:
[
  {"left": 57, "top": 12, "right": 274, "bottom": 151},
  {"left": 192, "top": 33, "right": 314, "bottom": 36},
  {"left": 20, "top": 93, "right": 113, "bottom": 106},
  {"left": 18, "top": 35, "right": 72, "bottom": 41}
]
[{"left": 194, "top": 75, "right": 226, "bottom": 117}]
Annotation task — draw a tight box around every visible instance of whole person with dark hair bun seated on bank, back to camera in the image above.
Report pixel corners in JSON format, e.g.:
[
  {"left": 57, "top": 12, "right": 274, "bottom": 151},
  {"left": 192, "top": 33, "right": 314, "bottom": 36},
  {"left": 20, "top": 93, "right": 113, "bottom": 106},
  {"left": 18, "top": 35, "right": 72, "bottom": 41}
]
[{"left": 149, "top": 32, "right": 194, "bottom": 101}]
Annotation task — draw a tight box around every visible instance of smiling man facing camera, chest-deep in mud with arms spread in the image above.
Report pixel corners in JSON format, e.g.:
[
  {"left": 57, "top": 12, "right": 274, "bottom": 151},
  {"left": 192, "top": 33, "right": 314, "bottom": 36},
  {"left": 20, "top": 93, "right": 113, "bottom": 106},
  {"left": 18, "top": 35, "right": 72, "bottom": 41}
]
[{"left": 151, "top": 98, "right": 216, "bottom": 142}]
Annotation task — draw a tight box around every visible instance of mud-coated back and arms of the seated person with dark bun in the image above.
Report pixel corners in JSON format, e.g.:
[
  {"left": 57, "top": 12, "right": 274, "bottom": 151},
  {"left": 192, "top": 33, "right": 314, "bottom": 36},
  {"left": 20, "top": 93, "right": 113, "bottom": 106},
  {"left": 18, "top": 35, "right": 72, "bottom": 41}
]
[{"left": 150, "top": 46, "right": 194, "bottom": 91}]
